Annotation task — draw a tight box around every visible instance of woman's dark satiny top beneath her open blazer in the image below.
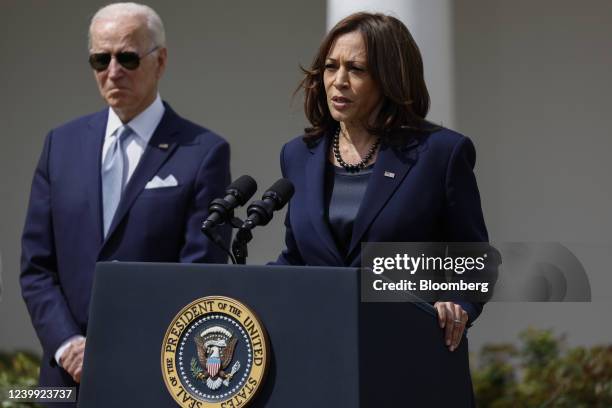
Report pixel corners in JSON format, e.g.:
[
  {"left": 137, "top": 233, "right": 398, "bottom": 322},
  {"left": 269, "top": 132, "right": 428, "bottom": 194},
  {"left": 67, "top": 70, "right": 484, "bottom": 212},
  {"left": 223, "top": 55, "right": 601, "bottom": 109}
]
[{"left": 325, "top": 162, "right": 374, "bottom": 256}]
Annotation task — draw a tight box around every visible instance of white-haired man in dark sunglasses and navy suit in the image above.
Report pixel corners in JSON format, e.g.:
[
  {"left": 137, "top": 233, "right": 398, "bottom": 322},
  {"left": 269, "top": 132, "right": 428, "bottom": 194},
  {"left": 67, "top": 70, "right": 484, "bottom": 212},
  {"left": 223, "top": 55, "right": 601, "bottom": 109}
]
[{"left": 21, "top": 3, "right": 230, "bottom": 386}]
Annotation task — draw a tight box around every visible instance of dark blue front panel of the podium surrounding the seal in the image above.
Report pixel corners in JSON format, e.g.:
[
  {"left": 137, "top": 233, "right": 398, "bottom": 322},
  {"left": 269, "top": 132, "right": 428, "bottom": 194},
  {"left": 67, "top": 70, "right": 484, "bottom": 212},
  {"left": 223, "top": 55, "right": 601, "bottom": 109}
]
[{"left": 79, "top": 262, "right": 359, "bottom": 408}]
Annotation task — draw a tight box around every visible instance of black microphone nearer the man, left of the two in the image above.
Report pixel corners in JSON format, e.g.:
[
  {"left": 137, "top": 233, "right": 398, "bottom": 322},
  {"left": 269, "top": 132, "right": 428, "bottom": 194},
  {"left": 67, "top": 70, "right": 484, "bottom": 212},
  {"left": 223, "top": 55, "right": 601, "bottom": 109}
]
[{"left": 201, "top": 175, "right": 257, "bottom": 234}]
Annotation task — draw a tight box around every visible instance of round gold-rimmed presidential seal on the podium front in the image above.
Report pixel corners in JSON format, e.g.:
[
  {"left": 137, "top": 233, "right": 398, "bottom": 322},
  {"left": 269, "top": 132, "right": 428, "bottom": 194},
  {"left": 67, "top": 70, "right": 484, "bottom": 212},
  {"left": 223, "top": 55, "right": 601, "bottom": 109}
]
[{"left": 161, "top": 296, "right": 269, "bottom": 408}]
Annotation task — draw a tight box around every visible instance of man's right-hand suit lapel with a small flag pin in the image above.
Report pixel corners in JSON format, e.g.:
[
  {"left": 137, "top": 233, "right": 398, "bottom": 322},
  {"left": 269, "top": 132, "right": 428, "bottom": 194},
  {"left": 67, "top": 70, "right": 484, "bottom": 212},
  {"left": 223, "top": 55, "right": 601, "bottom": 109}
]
[{"left": 103, "top": 105, "right": 178, "bottom": 247}]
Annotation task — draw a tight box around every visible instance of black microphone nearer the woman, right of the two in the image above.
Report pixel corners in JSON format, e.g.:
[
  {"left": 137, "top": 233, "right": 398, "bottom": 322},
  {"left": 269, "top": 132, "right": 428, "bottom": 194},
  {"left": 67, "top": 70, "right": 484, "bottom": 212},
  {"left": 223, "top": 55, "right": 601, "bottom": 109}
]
[{"left": 241, "top": 178, "right": 295, "bottom": 230}]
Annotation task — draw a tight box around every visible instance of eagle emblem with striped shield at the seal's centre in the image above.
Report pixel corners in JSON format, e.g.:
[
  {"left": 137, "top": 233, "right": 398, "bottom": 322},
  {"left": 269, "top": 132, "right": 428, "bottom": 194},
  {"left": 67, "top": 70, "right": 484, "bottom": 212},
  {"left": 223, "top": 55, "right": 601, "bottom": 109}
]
[{"left": 191, "top": 326, "right": 240, "bottom": 390}]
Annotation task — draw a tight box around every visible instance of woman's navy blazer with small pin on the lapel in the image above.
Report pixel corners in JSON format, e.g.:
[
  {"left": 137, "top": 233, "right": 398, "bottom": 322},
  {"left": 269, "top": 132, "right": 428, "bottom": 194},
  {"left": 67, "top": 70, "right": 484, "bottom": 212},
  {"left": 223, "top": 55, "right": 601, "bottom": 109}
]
[{"left": 276, "top": 128, "right": 488, "bottom": 323}]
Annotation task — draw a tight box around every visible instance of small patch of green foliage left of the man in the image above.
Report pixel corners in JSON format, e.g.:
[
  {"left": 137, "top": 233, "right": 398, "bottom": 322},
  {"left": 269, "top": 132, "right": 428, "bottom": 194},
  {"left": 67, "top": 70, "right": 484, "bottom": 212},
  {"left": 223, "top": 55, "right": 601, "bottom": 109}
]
[{"left": 0, "top": 351, "right": 40, "bottom": 408}]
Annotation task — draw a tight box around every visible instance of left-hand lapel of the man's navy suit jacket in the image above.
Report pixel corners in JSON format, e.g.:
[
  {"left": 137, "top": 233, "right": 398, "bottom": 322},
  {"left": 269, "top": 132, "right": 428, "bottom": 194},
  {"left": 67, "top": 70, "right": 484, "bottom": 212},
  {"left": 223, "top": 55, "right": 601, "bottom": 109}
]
[{"left": 84, "top": 109, "right": 108, "bottom": 243}]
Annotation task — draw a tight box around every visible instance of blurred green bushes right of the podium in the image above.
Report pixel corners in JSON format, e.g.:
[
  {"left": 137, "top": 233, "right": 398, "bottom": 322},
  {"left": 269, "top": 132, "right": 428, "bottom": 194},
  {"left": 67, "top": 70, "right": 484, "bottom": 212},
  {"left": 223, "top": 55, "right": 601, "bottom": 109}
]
[{"left": 472, "top": 329, "right": 612, "bottom": 408}]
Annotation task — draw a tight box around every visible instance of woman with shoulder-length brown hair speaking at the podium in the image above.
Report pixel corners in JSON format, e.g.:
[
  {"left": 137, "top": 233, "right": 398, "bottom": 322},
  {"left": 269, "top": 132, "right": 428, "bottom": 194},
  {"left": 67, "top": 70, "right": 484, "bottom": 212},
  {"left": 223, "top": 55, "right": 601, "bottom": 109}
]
[{"left": 276, "top": 13, "right": 488, "bottom": 351}]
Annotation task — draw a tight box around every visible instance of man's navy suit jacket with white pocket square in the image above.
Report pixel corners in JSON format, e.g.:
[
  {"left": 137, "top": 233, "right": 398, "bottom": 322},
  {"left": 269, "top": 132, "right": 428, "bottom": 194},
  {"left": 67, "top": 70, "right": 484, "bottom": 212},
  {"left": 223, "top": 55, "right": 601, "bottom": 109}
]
[{"left": 21, "top": 105, "right": 230, "bottom": 385}]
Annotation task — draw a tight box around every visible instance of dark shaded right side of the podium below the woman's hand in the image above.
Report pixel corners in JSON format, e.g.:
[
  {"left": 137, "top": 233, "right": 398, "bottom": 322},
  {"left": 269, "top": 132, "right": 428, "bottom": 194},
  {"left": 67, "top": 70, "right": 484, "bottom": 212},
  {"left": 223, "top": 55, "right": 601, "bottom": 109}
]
[{"left": 359, "top": 303, "right": 474, "bottom": 408}]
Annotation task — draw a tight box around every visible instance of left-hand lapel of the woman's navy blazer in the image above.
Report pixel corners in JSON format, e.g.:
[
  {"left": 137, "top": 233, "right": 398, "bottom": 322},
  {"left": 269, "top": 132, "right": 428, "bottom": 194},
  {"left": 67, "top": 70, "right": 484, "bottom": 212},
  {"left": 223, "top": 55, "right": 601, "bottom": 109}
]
[{"left": 304, "top": 136, "right": 344, "bottom": 265}]
